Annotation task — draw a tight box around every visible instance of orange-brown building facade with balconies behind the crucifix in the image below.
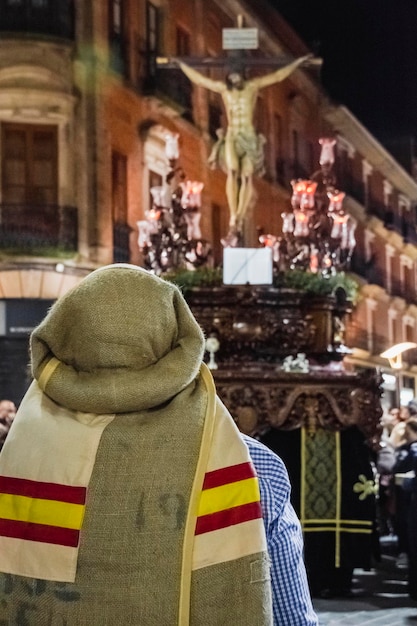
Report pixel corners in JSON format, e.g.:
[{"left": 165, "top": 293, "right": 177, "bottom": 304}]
[{"left": 0, "top": 0, "right": 417, "bottom": 402}]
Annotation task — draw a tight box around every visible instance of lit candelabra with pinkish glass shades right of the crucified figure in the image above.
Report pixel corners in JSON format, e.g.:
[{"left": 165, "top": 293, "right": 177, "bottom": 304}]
[{"left": 259, "top": 138, "right": 357, "bottom": 276}]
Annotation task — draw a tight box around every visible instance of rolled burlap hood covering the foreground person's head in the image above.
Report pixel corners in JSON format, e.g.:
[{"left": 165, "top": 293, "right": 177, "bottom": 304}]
[{"left": 30, "top": 264, "right": 204, "bottom": 413}]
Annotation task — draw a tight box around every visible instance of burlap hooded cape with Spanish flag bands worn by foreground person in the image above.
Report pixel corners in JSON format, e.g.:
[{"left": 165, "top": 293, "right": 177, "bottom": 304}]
[{"left": 0, "top": 265, "right": 272, "bottom": 626}]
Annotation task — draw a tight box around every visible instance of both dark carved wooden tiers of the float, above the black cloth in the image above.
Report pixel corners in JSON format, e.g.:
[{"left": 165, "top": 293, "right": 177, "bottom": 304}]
[{"left": 187, "top": 285, "right": 381, "bottom": 448}]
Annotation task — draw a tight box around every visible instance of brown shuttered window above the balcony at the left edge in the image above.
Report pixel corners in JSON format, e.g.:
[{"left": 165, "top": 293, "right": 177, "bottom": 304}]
[{"left": 1, "top": 124, "right": 58, "bottom": 204}]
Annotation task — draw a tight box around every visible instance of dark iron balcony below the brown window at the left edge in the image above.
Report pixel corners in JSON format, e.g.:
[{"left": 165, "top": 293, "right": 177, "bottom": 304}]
[{"left": 0, "top": 204, "right": 78, "bottom": 257}]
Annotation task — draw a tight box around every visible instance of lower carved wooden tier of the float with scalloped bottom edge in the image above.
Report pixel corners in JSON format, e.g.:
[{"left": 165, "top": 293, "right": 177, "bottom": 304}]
[{"left": 215, "top": 368, "right": 381, "bottom": 448}]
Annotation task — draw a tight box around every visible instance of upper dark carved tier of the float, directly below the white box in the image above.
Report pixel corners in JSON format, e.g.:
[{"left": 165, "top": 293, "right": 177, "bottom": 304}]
[{"left": 187, "top": 285, "right": 348, "bottom": 364}]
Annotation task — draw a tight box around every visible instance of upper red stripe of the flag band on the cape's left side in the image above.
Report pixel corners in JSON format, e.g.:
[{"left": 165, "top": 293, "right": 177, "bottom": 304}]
[{"left": 0, "top": 476, "right": 87, "bottom": 504}]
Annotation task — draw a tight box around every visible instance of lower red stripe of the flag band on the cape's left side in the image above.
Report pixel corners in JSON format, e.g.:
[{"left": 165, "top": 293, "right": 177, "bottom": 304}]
[{"left": 0, "top": 519, "right": 80, "bottom": 548}]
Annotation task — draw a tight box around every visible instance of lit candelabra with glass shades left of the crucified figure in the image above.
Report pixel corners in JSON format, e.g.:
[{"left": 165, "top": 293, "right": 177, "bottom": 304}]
[{"left": 137, "top": 134, "right": 211, "bottom": 274}]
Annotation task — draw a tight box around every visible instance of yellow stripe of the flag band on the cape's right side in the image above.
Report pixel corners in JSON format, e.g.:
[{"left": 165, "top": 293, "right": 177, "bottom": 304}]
[{"left": 198, "top": 478, "right": 260, "bottom": 516}]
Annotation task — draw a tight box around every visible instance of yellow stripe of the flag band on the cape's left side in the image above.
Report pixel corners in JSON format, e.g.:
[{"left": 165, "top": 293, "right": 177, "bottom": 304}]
[{"left": 0, "top": 494, "right": 85, "bottom": 529}]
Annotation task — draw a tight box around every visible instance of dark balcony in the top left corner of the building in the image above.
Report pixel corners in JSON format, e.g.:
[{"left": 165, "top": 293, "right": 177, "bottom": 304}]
[{"left": 0, "top": 0, "right": 74, "bottom": 39}]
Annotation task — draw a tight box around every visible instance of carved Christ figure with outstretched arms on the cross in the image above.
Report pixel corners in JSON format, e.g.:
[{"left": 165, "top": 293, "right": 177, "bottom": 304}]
[{"left": 158, "top": 19, "right": 317, "bottom": 245}]
